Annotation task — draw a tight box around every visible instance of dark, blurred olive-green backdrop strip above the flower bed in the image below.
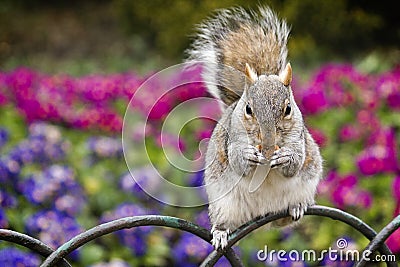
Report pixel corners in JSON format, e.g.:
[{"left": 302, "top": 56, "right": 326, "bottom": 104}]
[{"left": 0, "top": 0, "right": 400, "bottom": 74}]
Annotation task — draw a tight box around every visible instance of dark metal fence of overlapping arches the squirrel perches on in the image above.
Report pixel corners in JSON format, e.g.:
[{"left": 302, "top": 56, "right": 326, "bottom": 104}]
[{"left": 0, "top": 205, "right": 400, "bottom": 267}]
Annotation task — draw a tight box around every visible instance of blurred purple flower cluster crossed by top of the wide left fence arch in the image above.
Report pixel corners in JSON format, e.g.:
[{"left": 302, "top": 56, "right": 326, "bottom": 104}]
[{"left": 101, "top": 204, "right": 154, "bottom": 256}]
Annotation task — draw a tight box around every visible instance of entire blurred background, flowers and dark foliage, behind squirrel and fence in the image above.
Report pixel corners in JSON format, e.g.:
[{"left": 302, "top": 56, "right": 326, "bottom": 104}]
[{"left": 0, "top": 0, "right": 400, "bottom": 267}]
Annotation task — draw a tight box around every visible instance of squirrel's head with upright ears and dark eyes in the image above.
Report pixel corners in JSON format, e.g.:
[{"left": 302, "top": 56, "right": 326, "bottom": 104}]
[{"left": 240, "top": 63, "right": 301, "bottom": 156}]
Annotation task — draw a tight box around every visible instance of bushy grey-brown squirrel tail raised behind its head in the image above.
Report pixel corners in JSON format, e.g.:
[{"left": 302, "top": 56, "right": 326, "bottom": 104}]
[{"left": 187, "top": 7, "right": 289, "bottom": 105}]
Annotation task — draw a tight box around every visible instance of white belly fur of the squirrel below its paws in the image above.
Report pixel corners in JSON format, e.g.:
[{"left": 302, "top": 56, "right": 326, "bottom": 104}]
[{"left": 207, "top": 166, "right": 318, "bottom": 229}]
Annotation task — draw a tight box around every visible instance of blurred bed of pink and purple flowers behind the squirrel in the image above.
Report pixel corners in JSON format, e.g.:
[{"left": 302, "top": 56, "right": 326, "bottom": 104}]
[{"left": 0, "top": 64, "right": 400, "bottom": 266}]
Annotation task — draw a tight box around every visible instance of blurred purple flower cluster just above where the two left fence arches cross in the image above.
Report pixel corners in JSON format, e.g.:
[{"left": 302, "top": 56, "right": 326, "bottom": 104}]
[{"left": 25, "top": 210, "right": 82, "bottom": 257}]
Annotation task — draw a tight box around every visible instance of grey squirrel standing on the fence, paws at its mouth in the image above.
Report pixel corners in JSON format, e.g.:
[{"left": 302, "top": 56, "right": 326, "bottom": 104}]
[{"left": 187, "top": 7, "right": 323, "bottom": 249}]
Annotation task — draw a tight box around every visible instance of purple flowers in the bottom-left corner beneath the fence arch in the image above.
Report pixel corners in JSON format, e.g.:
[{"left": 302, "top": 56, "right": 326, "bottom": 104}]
[{"left": 0, "top": 248, "right": 41, "bottom": 267}]
